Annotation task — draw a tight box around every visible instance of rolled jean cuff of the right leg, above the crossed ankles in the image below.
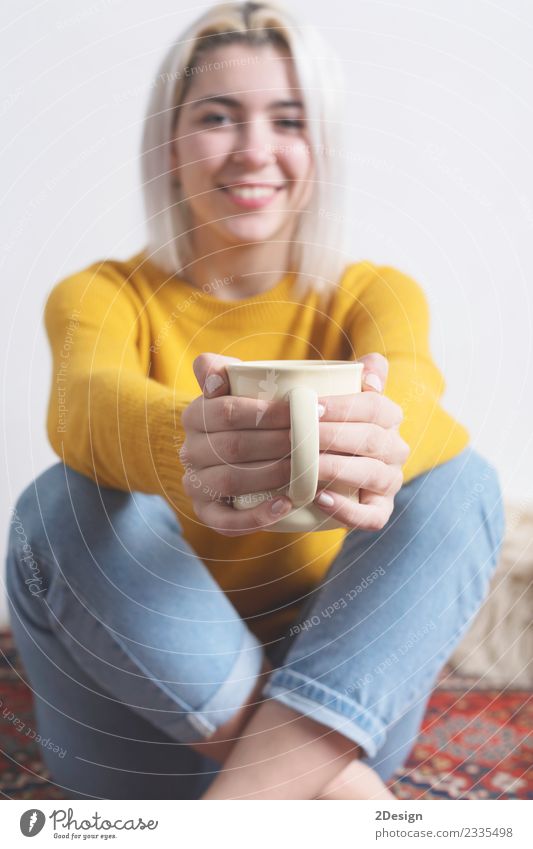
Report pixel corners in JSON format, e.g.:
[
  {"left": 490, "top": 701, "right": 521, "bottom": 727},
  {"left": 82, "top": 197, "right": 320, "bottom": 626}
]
[{"left": 262, "top": 669, "right": 387, "bottom": 757}]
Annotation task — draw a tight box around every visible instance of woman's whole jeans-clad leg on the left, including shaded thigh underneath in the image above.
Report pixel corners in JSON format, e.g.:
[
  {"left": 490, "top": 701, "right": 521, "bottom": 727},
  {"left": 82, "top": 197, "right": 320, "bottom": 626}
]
[{"left": 7, "top": 463, "right": 265, "bottom": 798}]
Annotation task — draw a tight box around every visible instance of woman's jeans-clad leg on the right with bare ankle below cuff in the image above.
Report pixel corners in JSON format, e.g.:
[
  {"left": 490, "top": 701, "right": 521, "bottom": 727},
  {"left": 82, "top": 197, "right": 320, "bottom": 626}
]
[{"left": 204, "top": 447, "right": 504, "bottom": 798}]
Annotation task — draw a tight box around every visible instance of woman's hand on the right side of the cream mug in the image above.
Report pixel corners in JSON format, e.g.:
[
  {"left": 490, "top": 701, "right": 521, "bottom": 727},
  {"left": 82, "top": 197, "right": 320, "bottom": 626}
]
[{"left": 315, "top": 353, "right": 411, "bottom": 531}]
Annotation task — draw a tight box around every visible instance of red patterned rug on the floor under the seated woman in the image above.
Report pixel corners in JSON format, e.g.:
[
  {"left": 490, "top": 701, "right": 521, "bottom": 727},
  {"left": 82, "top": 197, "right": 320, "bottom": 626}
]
[{"left": 0, "top": 631, "right": 533, "bottom": 799}]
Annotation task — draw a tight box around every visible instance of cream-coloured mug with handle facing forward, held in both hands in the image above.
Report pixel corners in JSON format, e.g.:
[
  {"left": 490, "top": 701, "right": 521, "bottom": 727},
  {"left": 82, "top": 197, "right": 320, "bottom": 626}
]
[{"left": 222, "top": 360, "right": 363, "bottom": 532}]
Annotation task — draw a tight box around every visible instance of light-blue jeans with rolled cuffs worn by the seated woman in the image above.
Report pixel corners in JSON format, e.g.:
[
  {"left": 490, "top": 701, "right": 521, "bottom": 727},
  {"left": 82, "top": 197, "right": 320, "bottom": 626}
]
[{"left": 6, "top": 446, "right": 505, "bottom": 799}]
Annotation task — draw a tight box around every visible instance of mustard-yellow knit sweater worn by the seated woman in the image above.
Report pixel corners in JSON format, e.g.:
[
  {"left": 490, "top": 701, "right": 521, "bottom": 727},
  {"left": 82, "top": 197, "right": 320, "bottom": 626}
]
[{"left": 45, "top": 251, "right": 469, "bottom": 642}]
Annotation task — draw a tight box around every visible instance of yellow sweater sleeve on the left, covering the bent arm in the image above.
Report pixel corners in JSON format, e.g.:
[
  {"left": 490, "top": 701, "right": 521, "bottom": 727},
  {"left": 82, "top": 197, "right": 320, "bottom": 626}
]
[{"left": 44, "top": 266, "right": 193, "bottom": 507}]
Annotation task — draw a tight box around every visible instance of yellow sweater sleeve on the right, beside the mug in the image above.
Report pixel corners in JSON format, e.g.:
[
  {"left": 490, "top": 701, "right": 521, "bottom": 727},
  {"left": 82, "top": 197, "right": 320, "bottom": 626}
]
[{"left": 350, "top": 266, "right": 469, "bottom": 483}]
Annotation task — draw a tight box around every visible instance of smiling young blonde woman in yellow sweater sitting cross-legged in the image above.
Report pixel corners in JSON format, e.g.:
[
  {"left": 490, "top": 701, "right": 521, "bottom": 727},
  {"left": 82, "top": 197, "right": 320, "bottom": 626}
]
[{"left": 7, "top": 3, "right": 504, "bottom": 799}]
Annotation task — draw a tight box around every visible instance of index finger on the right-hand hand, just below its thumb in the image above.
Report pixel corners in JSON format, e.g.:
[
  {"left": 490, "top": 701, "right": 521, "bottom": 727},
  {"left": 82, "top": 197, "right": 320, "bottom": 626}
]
[{"left": 318, "top": 392, "right": 403, "bottom": 428}]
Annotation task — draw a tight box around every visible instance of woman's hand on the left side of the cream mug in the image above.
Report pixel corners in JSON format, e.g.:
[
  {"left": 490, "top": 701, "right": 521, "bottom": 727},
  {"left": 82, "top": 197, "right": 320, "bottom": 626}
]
[{"left": 180, "top": 353, "right": 292, "bottom": 536}]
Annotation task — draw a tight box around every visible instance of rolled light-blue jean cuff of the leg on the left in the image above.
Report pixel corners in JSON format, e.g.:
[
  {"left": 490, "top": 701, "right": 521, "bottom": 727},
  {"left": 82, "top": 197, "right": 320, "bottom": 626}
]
[{"left": 183, "top": 629, "right": 264, "bottom": 743}]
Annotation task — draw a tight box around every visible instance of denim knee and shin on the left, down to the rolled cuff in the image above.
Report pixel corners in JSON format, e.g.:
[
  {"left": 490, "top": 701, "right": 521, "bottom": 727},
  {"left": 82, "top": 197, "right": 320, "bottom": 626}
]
[{"left": 8, "top": 464, "right": 263, "bottom": 743}]
